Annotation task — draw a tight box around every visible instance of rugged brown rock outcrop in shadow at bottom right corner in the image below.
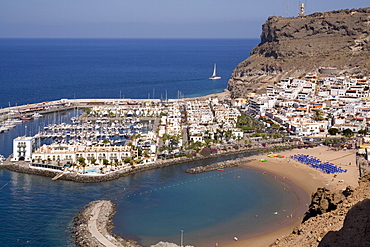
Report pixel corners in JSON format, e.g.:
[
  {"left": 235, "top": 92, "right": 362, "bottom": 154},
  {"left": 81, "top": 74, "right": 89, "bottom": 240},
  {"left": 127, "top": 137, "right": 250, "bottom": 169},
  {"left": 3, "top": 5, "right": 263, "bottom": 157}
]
[{"left": 270, "top": 173, "right": 370, "bottom": 247}]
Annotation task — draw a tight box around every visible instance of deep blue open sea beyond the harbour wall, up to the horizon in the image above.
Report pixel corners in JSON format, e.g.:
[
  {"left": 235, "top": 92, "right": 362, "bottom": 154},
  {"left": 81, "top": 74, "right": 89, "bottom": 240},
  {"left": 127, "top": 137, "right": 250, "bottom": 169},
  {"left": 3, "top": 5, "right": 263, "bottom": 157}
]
[{"left": 0, "top": 39, "right": 259, "bottom": 107}]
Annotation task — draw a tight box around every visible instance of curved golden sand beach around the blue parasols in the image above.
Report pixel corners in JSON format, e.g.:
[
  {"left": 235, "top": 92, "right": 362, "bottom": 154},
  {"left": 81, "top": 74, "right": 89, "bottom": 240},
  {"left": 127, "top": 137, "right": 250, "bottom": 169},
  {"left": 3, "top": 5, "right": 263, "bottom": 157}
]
[{"left": 219, "top": 146, "right": 359, "bottom": 247}]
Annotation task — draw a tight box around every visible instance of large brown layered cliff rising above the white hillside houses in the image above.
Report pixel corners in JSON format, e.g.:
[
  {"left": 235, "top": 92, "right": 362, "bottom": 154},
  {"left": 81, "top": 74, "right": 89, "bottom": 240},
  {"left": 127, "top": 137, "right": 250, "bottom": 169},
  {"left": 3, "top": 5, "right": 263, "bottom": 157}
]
[{"left": 228, "top": 8, "right": 370, "bottom": 98}]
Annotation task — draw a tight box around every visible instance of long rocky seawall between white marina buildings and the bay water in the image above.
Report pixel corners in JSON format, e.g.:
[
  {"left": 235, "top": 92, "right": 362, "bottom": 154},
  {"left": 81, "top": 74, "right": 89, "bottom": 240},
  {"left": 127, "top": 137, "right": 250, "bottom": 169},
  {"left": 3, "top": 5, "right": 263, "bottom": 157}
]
[{"left": 0, "top": 143, "right": 297, "bottom": 183}]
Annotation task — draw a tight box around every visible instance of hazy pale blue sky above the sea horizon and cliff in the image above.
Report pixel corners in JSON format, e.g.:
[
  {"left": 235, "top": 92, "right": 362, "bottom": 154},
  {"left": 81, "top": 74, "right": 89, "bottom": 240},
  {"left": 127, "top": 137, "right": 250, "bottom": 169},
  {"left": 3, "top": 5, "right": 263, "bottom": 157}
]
[{"left": 0, "top": 0, "right": 370, "bottom": 38}]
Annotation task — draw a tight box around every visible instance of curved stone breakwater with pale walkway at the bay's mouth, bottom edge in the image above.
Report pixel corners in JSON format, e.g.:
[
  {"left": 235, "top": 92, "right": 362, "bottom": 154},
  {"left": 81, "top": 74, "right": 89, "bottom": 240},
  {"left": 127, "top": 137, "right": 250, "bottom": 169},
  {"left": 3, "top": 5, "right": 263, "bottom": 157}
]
[{"left": 71, "top": 200, "right": 140, "bottom": 247}]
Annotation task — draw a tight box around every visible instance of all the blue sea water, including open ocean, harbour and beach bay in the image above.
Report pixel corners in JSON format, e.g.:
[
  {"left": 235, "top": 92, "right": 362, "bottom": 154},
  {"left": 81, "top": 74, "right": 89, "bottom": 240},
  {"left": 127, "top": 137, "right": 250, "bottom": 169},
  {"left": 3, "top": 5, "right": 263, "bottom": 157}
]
[{"left": 0, "top": 39, "right": 300, "bottom": 247}]
